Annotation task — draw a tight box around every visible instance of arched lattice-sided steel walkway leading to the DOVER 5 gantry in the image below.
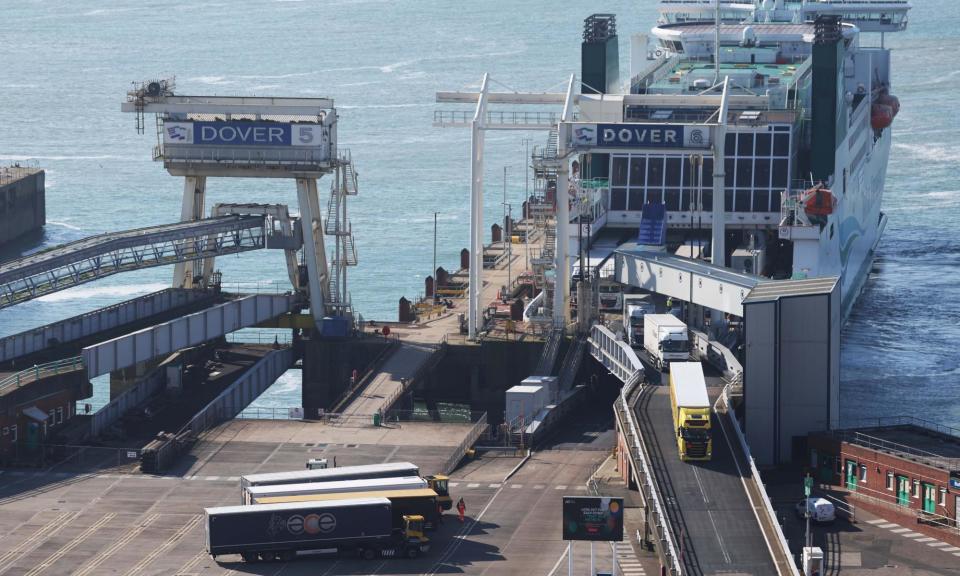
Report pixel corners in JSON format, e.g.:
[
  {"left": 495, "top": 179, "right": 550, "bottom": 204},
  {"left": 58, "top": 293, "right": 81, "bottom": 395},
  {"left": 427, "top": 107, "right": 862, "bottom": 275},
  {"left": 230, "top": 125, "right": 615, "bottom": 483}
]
[{"left": 0, "top": 215, "right": 266, "bottom": 308}]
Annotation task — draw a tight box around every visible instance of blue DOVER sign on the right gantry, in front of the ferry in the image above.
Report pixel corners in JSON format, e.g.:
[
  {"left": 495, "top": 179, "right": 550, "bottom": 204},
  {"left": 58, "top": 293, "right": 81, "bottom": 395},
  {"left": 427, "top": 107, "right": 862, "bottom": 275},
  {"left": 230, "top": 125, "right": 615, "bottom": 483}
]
[{"left": 570, "top": 124, "right": 710, "bottom": 148}]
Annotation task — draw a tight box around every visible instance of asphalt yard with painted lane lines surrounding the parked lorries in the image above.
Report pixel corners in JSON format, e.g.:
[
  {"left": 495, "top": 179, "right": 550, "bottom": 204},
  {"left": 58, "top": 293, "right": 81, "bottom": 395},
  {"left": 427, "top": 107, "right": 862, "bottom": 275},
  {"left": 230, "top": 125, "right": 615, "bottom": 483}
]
[{"left": 0, "top": 394, "right": 626, "bottom": 576}]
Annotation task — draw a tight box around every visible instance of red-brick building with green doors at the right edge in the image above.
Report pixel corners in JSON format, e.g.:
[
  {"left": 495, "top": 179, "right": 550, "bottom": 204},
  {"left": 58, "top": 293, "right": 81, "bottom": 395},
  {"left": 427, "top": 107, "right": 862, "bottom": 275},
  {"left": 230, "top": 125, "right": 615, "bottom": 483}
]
[{"left": 809, "top": 418, "right": 960, "bottom": 545}]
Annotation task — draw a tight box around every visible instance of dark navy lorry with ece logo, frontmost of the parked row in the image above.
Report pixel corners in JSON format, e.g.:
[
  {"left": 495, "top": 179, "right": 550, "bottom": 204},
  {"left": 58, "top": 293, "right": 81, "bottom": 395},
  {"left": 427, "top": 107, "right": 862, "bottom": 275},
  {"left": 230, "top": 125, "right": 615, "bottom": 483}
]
[{"left": 204, "top": 498, "right": 430, "bottom": 562}]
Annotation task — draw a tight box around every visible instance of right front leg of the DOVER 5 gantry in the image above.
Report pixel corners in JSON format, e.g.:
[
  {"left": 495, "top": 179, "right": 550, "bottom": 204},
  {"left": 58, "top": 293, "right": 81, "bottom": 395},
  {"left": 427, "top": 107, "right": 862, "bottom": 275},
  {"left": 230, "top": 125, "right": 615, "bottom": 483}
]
[{"left": 297, "top": 178, "right": 330, "bottom": 330}]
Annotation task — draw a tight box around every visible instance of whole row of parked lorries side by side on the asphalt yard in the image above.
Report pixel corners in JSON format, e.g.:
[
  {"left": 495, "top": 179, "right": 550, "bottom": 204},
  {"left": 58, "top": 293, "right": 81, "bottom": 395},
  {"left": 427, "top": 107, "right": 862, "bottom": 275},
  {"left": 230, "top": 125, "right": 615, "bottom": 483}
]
[{"left": 205, "top": 462, "right": 452, "bottom": 562}]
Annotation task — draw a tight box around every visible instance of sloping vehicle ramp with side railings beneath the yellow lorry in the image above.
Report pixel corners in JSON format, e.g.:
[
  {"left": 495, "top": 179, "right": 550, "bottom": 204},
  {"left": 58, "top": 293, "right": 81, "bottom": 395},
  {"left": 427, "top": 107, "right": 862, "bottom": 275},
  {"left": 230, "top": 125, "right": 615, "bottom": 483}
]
[{"left": 589, "top": 325, "right": 797, "bottom": 576}]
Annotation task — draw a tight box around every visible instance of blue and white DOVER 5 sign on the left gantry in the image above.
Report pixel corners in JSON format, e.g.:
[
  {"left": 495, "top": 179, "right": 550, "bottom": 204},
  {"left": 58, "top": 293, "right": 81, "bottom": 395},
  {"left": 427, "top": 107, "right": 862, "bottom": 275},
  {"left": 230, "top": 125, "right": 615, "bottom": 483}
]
[{"left": 163, "top": 121, "right": 329, "bottom": 148}]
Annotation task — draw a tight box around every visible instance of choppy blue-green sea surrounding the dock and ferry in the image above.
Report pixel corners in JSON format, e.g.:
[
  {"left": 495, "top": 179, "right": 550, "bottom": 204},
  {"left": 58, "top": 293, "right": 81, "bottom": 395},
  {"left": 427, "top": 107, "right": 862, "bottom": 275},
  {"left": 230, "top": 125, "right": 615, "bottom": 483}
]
[{"left": 0, "top": 0, "right": 960, "bottom": 427}]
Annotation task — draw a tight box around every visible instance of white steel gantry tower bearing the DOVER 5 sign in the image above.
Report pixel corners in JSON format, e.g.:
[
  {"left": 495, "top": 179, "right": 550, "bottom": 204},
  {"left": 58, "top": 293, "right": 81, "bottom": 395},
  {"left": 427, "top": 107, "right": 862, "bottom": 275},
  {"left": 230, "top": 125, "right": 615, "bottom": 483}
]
[{"left": 121, "top": 79, "right": 356, "bottom": 328}]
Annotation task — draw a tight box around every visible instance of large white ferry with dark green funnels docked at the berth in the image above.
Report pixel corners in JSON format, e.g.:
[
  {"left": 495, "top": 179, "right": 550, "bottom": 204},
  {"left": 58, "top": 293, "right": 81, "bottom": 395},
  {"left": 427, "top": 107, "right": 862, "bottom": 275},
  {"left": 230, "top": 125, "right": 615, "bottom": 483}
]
[{"left": 569, "top": 0, "right": 910, "bottom": 318}]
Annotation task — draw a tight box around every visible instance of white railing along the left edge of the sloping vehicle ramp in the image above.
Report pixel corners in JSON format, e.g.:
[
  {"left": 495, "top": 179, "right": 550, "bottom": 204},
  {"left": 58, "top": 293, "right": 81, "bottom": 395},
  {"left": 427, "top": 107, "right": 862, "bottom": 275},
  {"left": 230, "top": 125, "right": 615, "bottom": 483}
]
[{"left": 614, "top": 372, "right": 683, "bottom": 576}]
